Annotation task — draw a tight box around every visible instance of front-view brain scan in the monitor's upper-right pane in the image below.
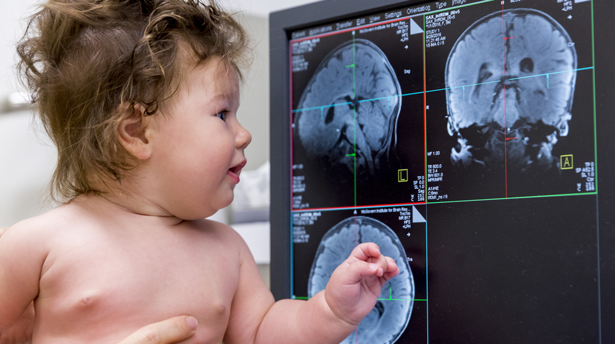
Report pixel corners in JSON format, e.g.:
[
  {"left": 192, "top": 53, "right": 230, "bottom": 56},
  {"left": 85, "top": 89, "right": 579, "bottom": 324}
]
[{"left": 445, "top": 9, "right": 577, "bottom": 172}]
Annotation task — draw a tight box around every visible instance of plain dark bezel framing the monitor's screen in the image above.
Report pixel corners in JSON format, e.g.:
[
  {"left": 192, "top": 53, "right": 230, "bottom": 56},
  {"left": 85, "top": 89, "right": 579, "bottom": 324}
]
[{"left": 269, "top": 0, "right": 615, "bottom": 342}]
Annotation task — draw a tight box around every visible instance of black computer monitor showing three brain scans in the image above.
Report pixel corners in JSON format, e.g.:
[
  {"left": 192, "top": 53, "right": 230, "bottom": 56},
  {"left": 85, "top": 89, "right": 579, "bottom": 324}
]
[{"left": 270, "top": 0, "right": 615, "bottom": 344}]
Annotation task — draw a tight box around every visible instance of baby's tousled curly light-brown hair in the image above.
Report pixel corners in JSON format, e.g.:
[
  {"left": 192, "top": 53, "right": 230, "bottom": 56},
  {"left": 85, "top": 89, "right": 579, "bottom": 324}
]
[{"left": 17, "top": 0, "right": 247, "bottom": 202}]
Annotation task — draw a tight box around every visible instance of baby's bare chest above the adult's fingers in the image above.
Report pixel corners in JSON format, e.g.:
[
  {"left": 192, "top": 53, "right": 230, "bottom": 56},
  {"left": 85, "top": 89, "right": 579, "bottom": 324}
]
[{"left": 37, "top": 226, "right": 239, "bottom": 343}]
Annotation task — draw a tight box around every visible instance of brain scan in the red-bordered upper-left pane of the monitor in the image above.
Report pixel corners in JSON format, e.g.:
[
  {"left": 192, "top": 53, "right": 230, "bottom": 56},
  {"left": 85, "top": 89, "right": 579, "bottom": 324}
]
[{"left": 295, "top": 39, "right": 401, "bottom": 176}]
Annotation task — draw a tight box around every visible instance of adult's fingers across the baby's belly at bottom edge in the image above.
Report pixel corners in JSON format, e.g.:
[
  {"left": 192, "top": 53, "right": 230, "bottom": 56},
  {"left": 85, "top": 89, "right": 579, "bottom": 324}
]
[{"left": 119, "top": 315, "right": 198, "bottom": 344}]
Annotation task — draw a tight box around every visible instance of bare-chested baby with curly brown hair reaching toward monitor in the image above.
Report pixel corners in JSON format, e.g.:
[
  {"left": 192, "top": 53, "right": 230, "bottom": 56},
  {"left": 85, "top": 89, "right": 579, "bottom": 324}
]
[{"left": 0, "top": 0, "right": 399, "bottom": 344}]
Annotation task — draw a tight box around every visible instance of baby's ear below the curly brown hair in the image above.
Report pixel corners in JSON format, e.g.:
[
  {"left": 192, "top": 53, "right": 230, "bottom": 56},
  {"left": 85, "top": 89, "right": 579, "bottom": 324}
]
[{"left": 116, "top": 104, "right": 153, "bottom": 160}]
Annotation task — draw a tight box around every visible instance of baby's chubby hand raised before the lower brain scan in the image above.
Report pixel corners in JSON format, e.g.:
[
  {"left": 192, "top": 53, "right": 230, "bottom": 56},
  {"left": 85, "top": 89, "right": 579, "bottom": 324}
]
[{"left": 325, "top": 243, "right": 399, "bottom": 325}]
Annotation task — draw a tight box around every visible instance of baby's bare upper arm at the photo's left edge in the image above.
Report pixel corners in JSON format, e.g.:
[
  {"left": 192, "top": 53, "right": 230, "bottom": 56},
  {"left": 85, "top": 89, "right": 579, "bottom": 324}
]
[{"left": 0, "top": 219, "right": 47, "bottom": 333}]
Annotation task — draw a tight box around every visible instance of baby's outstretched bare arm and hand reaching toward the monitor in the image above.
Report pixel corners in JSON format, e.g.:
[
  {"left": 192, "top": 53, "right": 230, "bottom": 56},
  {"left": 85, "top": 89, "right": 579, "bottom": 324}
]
[{"left": 224, "top": 236, "right": 399, "bottom": 344}]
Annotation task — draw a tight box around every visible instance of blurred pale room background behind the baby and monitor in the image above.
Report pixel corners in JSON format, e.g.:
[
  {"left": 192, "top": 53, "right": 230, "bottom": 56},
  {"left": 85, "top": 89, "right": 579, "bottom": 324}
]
[{"left": 0, "top": 0, "right": 314, "bottom": 285}]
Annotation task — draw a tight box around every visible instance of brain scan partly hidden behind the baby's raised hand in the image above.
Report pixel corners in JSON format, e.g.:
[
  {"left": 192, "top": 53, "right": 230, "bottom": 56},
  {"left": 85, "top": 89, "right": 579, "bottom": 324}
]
[{"left": 308, "top": 216, "right": 414, "bottom": 344}]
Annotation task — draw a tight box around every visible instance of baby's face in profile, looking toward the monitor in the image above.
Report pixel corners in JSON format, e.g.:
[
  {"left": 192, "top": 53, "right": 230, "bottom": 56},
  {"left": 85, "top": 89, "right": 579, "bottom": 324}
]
[{"left": 150, "top": 58, "right": 252, "bottom": 220}]
